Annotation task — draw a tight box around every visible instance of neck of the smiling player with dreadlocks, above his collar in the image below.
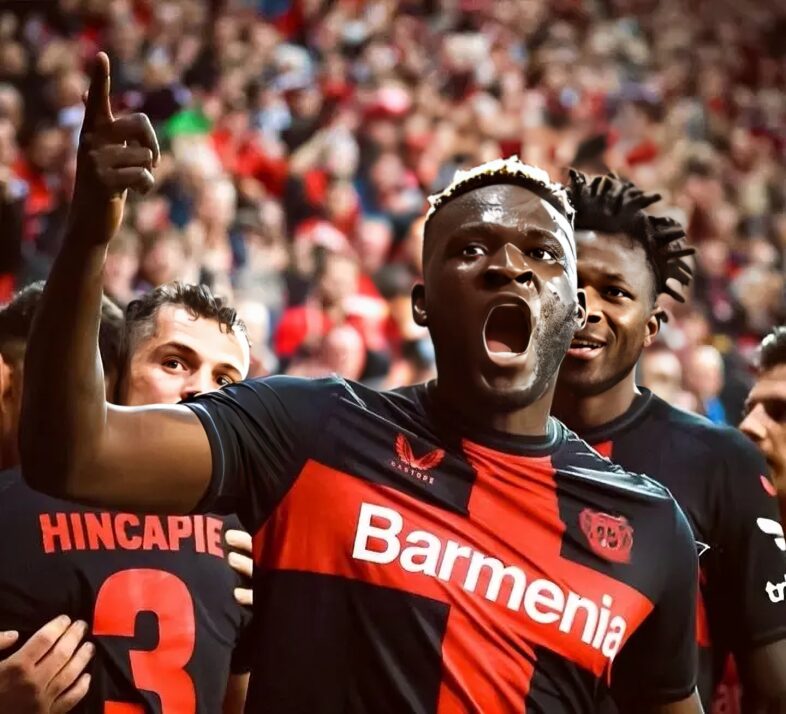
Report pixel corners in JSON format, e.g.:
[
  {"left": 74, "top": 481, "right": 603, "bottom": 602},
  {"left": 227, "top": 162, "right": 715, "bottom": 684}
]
[{"left": 553, "top": 370, "right": 640, "bottom": 434}]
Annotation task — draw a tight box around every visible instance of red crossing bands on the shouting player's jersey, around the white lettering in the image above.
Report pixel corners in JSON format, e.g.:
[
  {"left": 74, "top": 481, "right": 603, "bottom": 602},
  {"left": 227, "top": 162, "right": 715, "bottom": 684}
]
[{"left": 254, "top": 454, "right": 652, "bottom": 714}]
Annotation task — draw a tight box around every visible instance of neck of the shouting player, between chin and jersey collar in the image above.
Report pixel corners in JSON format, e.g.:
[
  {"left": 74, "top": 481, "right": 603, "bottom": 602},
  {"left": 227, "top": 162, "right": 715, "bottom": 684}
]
[{"left": 434, "top": 380, "right": 554, "bottom": 436}]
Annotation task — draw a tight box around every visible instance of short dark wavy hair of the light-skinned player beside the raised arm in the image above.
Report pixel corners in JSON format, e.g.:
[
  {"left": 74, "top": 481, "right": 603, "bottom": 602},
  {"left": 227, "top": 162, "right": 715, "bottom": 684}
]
[{"left": 126, "top": 280, "right": 251, "bottom": 355}]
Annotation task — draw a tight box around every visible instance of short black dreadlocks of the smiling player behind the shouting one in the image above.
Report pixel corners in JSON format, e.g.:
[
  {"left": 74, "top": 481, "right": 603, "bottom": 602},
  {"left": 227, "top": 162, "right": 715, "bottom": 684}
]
[{"left": 568, "top": 169, "right": 696, "bottom": 302}]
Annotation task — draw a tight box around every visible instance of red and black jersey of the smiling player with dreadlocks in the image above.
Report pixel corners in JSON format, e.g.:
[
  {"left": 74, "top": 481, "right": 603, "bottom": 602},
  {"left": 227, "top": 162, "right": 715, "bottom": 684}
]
[{"left": 581, "top": 389, "right": 786, "bottom": 711}]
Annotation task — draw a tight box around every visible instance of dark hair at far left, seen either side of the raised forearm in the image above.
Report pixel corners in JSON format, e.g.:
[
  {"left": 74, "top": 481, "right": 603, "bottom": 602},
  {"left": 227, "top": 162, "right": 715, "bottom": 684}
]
[{"left": 0, "top": 280, "right": 125, "bottom": 374}]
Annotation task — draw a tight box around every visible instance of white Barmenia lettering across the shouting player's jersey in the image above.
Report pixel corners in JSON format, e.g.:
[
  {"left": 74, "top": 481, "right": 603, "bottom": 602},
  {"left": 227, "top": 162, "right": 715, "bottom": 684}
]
[{"left": 352, "top": 503, "right": 628, "bottom": 660}]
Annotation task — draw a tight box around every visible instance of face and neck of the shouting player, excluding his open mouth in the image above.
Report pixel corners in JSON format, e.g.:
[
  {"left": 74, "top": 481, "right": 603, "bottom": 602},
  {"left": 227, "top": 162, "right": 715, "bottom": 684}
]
[{"left": 413, "top": 184, "right": 584, "bottom": 435}]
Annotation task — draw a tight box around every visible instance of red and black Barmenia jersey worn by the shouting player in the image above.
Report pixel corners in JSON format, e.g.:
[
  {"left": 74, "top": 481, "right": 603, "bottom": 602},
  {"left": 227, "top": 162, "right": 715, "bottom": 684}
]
[{"left": 188, "top": 377, "right": 698, "bottom": 714}]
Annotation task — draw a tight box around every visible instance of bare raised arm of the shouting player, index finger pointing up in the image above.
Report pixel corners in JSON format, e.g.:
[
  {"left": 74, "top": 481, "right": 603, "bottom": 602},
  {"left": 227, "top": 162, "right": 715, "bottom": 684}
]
[{"left": 20, "top": 53, "right": 211, "bottom": 512}]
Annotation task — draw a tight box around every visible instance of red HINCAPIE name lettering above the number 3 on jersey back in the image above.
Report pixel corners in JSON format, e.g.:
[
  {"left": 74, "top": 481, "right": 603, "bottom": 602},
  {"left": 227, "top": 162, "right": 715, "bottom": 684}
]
[{"left": 38, "top": 512, "right": 224, "bottom": 558}]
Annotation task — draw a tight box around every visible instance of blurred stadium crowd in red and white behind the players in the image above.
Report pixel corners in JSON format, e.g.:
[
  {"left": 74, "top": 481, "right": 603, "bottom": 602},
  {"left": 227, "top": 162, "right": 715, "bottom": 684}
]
[{"left": 0, "top": 0, "right": 786, "bottom": 423}]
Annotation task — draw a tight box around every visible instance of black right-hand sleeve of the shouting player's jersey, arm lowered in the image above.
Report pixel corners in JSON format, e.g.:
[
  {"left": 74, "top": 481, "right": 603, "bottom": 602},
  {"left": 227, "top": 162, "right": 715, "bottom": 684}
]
[{"left": 612, "top": 503, "right": 699, "bottom": 711}]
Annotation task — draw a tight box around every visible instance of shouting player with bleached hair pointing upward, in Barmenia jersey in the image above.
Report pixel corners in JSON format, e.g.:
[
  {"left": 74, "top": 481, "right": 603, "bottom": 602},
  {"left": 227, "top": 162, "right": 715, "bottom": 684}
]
[{"left": 20, "top": 55, "right": 701, "bottom": 714}]
